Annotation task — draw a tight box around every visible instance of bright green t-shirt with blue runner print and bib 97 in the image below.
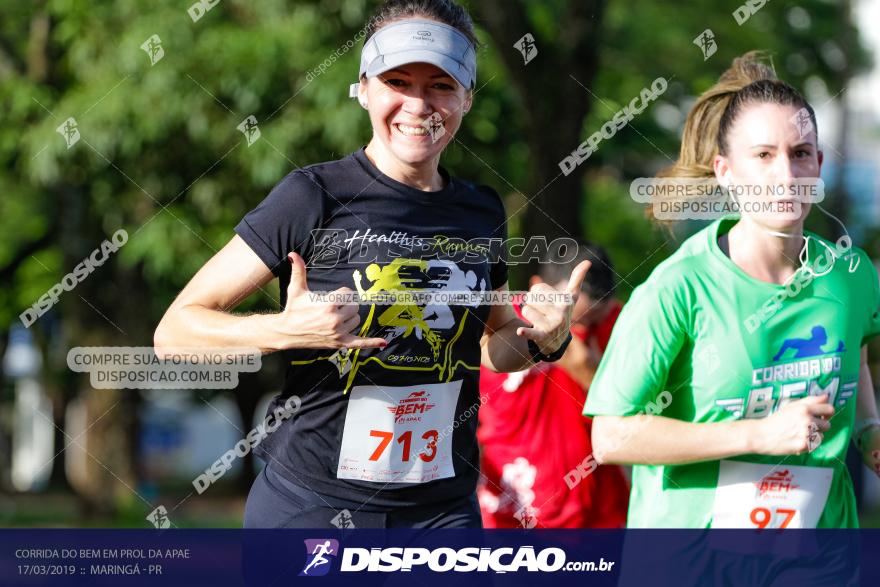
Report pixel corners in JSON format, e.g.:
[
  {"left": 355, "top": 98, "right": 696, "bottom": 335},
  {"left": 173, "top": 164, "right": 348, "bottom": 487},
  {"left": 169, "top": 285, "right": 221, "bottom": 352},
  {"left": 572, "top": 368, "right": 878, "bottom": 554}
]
[{"left": 584, "top": 216, "right": 880, "bottom": 528}]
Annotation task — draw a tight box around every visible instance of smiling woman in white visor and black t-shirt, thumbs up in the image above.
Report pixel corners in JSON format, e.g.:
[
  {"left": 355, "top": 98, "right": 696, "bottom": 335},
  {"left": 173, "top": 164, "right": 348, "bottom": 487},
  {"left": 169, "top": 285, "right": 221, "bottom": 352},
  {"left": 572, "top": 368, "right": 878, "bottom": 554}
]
[{"left": 155, "top": 0, "right": 589, "bottom": 528}]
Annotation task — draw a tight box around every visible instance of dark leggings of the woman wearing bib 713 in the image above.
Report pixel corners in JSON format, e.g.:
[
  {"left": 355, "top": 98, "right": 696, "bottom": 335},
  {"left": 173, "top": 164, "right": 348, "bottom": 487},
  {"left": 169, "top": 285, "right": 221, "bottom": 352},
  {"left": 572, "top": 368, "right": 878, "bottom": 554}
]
[{"left": 244, "top": 466, "right": 483, "bottom": 529}]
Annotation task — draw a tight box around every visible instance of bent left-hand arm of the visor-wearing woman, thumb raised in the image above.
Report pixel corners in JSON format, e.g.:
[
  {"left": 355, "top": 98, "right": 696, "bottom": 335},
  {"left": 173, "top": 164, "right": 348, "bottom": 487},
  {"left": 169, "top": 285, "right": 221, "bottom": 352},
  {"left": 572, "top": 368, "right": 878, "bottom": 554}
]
[{"left": 153, "top": 235, "right": 385, "bottom": 358}]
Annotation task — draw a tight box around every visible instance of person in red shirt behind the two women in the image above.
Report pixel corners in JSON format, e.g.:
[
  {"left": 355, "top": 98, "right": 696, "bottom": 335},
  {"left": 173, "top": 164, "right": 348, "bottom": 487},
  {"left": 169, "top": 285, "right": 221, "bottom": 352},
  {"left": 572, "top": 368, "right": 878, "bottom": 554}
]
[{"left": 477, "top": 243, "right": 629, "bottom": 528}]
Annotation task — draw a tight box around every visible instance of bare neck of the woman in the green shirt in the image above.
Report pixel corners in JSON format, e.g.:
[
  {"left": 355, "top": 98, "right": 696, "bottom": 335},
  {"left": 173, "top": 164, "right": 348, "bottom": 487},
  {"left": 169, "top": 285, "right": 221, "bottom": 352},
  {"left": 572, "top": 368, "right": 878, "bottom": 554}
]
[{"left": 726, "top": 218, "right": 804, "bottom": 284}]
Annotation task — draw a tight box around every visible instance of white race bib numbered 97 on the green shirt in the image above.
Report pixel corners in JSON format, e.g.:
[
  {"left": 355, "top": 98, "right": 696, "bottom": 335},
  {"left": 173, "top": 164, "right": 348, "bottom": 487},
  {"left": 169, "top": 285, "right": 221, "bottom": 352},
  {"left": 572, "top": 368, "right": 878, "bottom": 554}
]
[{"left": 712, "top": 461, "right": 834, "bottom": 529}]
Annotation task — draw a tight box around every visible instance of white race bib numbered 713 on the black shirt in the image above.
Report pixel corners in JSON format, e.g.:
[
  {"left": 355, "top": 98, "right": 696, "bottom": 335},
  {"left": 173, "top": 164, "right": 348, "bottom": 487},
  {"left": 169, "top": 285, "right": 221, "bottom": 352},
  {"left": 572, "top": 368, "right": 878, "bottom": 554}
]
[{"left": 336, "top": 380, "right": 461, "bottom": 483}]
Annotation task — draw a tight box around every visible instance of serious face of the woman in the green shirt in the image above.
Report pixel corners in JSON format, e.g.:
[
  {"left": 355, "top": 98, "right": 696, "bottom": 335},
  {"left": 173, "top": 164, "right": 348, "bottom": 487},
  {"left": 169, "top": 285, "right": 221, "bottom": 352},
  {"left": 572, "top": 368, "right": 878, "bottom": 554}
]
[{"left": 714, "top": 103, "right": 822, "bottom": 232}]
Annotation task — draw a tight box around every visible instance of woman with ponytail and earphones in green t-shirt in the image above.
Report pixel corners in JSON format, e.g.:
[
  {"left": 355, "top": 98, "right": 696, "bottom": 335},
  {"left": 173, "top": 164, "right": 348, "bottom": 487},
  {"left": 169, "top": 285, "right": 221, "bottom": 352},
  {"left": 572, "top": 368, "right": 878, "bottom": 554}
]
[{"left": 584, "top": 53, "right": 880, "bottom": 528}]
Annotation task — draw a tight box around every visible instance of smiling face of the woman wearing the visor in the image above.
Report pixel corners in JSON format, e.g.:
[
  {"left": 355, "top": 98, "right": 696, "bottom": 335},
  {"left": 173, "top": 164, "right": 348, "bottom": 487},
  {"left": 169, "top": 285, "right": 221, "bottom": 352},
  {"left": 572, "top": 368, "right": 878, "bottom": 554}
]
[{"left": 358, "top": 63, "right": 471, "bottom": 177}]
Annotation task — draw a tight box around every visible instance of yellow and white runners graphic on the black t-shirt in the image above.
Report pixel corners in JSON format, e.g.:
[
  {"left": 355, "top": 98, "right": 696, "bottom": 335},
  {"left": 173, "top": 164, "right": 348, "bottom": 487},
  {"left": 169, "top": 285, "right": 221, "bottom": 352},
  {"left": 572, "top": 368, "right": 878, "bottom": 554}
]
[{"left": 291, "top": 257, "right": 486, "bottom": 393}]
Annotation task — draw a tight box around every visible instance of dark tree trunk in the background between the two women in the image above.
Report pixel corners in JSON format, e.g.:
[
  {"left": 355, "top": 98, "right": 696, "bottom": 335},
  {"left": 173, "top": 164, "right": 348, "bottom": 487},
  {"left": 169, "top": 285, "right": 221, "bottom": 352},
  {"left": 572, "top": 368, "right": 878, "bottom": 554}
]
[{"left": 478, "top": 0, "right": 606, "bottom": 280}]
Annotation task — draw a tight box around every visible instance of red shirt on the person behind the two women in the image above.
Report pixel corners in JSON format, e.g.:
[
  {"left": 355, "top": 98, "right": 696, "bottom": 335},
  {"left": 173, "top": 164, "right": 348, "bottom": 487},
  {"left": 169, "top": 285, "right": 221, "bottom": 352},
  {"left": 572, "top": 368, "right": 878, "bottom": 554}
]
[{"left": 477, "top": 302, "right": 629, "bottom": 528}]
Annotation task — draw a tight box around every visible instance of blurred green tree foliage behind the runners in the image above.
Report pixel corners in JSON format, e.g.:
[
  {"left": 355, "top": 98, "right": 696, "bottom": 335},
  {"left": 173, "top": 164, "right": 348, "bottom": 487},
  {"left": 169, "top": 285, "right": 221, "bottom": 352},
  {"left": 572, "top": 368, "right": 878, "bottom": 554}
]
[{"left": 0, "top": 0, "right": 865, "bottom": 516}]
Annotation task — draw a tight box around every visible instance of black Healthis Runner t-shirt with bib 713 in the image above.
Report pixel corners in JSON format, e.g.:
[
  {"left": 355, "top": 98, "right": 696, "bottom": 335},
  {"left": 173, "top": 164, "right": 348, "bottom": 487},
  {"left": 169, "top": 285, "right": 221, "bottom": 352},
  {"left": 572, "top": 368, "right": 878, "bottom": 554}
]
[{"left": 235, "top": 149, "right": 507, "bottom": 509}]
